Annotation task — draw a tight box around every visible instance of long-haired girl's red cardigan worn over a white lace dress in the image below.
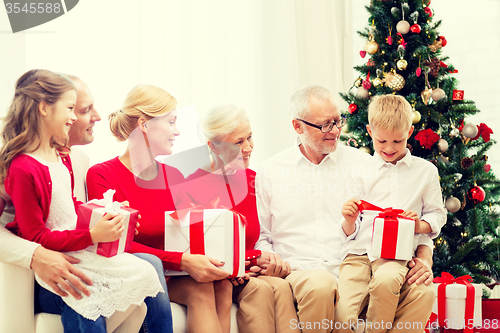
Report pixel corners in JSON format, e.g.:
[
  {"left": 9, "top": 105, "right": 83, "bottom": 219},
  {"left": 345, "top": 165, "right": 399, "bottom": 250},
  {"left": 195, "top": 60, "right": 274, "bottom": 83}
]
[{"left": 5, "top": 154, "right": 92, "bottom": 252}]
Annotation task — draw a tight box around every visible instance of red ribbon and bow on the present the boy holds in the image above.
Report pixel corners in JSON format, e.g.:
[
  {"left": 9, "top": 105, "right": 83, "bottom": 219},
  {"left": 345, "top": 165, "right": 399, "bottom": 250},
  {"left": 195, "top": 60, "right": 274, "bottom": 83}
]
[{"left": 358, "top": 200, "right": 413, "bottom": 258}]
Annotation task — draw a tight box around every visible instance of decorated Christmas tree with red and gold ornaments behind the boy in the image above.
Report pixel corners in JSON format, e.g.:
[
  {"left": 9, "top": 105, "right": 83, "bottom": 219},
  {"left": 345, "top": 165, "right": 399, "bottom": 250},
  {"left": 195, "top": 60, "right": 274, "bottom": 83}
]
[{"left": 341, "top": 0, "right": 500, "bottom": 284}]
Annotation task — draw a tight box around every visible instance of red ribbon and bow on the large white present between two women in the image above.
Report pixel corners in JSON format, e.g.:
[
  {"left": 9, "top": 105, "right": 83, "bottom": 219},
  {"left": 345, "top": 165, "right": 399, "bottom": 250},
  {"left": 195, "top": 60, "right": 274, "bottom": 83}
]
[{"left": 169, "top": 197, "right": 247, "bottom": 278}]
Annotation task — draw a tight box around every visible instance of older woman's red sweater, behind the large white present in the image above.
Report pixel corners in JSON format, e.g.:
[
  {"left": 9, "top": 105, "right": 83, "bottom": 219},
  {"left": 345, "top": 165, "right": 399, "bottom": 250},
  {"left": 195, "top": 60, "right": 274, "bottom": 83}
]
[{"left": 186, "top": 169, "right": 260, "bottom": 251}]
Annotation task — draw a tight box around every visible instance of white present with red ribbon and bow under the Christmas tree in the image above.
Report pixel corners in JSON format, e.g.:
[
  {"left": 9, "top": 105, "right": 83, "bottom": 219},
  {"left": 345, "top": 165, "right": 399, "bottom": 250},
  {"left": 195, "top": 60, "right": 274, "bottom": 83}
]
[{"left": 432, "top": 272, "right": 483, "bottom": 333}]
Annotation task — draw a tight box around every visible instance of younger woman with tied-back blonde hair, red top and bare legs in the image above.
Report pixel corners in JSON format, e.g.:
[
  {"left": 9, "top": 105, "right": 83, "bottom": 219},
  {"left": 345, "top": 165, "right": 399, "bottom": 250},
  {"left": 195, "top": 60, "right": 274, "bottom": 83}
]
[{"left": 87, "top": 85, "right": 231, "bottom": 333}]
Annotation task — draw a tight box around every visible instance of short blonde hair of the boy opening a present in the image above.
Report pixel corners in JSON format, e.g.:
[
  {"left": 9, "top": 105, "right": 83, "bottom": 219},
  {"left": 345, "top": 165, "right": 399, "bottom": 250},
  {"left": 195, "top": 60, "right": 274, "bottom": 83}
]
[{"left": 368, "top": 95, "right": 413, "bottom": 131}]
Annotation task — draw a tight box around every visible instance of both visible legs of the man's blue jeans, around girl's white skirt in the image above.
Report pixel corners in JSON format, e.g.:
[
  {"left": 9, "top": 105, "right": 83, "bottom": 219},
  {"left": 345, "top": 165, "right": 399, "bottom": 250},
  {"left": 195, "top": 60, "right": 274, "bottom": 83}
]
[{"left": 35, "top": 253, "right": 174, "bottom": 333}]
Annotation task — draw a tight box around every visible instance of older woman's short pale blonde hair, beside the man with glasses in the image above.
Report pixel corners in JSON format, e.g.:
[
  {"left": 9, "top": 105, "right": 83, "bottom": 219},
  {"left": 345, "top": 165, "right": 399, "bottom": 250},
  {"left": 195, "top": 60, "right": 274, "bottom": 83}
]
[{"left": 200, "top": 104, "right": 250, "bottom": 142}]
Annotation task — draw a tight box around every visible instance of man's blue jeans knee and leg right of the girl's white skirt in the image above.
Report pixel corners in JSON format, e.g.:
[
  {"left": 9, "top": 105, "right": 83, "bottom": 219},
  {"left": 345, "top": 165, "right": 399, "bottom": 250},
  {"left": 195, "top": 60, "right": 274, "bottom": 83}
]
[{"left": 134, "top": 253, "right": 174, "bottom": 333}]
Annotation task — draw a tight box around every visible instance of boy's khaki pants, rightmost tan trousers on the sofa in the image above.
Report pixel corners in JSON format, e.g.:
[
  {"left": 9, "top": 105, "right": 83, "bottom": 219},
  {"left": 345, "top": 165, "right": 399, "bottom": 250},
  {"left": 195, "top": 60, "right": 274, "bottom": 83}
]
[{"left": 335, "top": 255, "right": 435, "bottom": 333}]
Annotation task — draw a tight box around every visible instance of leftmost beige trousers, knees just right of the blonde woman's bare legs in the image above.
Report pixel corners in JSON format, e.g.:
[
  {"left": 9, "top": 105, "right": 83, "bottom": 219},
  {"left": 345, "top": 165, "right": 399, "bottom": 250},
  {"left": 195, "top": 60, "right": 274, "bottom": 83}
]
[{"left": 233, "top": 275, "right": 299, "bottom": 333}]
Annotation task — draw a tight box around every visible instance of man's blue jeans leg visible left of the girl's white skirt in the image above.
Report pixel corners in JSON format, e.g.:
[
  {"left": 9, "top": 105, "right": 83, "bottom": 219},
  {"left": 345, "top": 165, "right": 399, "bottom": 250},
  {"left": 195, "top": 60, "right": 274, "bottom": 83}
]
[{"left": 35, "top": 283, "right": 106, "bottom": 333}]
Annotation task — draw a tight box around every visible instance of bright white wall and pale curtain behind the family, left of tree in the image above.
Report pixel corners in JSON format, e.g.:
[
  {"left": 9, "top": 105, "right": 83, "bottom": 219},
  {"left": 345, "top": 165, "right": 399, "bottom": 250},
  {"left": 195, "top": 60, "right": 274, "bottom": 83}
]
[{"left": 0, "top": 0, "right": 352, "bottom": 166}]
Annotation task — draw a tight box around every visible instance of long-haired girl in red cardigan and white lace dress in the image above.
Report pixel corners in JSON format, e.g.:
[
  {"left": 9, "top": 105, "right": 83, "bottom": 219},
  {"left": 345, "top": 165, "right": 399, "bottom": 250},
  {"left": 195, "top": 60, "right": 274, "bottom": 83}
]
[{"left": 0, "top": 70, "right": 162, "bottom": 332}]
